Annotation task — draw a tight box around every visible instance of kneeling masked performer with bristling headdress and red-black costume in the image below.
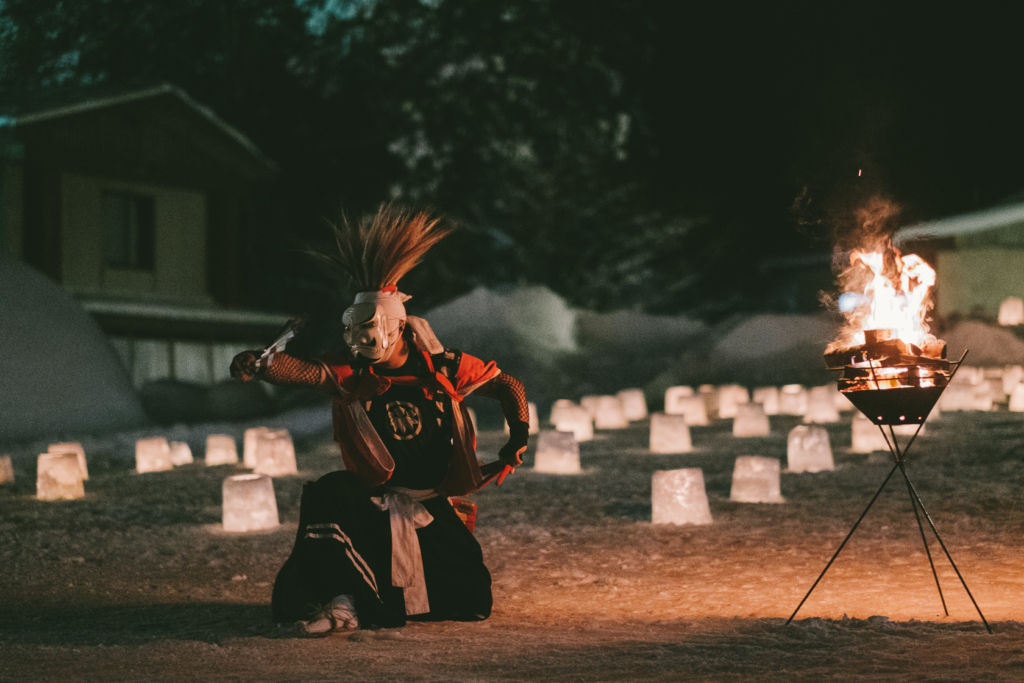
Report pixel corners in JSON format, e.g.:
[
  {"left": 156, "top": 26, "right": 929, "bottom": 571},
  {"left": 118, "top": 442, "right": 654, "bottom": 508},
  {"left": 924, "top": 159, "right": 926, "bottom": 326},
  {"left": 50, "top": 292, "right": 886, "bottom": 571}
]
[{"left": 231, "top": 207, "right": 529, "bottom": 636}]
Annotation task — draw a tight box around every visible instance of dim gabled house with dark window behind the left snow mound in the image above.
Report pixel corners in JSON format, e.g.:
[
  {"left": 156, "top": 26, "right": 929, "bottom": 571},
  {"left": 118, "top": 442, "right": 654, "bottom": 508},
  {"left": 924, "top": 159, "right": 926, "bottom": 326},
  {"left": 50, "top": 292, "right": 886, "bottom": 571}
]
[{"left": 0, "top": 84, "right": 285, "bottom": 385}]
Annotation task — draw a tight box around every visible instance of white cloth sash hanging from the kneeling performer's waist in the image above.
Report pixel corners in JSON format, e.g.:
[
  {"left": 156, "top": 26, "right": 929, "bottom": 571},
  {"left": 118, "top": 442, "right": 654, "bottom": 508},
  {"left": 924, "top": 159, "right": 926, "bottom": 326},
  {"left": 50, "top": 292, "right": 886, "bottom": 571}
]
[{"left": 370, "top": 486, "right": 437, "bottom": 614}]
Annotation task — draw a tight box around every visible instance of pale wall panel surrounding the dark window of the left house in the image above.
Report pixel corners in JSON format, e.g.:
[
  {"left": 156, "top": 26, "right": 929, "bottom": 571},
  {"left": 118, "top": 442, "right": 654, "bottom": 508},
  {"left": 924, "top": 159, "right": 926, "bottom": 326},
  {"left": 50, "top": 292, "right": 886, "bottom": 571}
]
[{"left": 61, "top": 174, "right": 209, "bottom": 303}]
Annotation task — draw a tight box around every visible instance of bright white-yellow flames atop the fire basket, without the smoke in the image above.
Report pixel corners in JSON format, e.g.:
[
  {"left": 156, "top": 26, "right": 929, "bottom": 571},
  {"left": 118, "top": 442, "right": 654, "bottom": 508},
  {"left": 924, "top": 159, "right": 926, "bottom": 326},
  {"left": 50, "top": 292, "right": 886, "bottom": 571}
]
[{"left": 831, "top": 245, "right": 935, "bottom": 347}]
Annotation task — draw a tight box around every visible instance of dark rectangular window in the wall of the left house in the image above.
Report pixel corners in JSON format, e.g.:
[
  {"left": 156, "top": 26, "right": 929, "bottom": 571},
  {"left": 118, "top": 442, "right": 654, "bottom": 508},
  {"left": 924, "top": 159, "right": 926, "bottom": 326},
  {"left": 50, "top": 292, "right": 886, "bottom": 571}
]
[{"left": 102, "top": 191, "right": 155, "bottom": 270}]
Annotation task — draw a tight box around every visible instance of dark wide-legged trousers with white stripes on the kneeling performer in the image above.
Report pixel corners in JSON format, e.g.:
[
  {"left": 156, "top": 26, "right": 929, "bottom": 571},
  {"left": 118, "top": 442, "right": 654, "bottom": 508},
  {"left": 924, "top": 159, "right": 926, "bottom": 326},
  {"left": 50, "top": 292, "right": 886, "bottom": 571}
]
[{"left": 270, "top": 471, "right": 492, "bottom": 627}]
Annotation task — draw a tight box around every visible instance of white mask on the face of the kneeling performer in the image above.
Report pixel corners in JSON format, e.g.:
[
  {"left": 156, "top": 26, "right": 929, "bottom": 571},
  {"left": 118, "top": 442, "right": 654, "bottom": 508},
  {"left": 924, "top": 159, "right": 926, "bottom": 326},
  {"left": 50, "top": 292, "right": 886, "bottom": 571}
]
[{"left": 341, "top": 290, "right": 412, "bottom": 362}]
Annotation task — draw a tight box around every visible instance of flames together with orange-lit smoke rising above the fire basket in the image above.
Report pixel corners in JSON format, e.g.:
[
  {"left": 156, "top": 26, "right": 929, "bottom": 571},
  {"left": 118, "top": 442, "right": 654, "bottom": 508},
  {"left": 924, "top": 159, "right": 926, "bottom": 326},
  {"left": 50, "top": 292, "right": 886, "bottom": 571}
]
[{"left": 822, "top": 198, "right": 935, "bottom": 353}]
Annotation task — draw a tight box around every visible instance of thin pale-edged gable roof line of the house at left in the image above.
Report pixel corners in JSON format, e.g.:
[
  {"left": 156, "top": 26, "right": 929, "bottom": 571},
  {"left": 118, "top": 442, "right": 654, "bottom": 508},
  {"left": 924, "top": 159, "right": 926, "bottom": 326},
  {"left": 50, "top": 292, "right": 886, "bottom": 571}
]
[{"left": 0, "top": 83, "right": 276, "bottom": 171}]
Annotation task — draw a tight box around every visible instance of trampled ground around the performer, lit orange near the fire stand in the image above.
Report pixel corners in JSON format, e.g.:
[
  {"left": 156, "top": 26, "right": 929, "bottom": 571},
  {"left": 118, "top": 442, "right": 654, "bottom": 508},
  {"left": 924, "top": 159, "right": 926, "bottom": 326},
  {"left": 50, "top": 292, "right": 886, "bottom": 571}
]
[{"left": 0, "top": 412, "right": 1024, "bottom": 683}]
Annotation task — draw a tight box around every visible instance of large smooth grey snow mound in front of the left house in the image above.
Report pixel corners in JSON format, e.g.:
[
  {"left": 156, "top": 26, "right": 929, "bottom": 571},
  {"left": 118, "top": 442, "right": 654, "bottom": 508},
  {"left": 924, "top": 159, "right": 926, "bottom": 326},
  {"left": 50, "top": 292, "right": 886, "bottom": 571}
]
[{"left": 0, "top": 258, "right": 146, "bottom": 442}]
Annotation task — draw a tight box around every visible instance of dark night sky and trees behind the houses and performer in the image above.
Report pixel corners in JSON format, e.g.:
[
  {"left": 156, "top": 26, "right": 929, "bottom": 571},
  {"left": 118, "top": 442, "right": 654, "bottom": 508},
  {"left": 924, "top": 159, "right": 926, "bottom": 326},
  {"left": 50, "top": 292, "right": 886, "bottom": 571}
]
[{"left": 0, "top": 0, "right": 1024, "bottom": 319}]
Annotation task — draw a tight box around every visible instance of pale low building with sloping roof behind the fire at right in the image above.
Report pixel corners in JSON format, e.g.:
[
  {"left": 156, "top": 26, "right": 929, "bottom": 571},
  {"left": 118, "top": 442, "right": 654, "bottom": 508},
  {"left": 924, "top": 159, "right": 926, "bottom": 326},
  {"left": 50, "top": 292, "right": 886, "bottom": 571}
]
[{"left": 893, "top": 201, "right": 1024, "bottom": 318}]
